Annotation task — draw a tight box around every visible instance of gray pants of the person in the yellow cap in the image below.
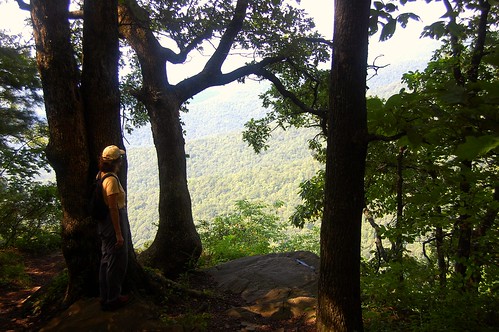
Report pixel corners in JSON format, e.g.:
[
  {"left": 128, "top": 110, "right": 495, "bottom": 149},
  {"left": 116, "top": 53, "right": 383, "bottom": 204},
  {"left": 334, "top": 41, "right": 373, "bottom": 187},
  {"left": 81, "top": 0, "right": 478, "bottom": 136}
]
[{"left": 98, "top": 208, "right": 131, "bottom": 303}]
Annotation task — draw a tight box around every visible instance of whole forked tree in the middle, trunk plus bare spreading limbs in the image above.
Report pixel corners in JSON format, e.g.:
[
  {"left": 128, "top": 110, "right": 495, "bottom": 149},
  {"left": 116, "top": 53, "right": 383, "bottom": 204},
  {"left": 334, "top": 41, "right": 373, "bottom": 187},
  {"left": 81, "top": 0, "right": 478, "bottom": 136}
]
[{"left": 119, "top": 0, "right": 308, "bottom": 276}]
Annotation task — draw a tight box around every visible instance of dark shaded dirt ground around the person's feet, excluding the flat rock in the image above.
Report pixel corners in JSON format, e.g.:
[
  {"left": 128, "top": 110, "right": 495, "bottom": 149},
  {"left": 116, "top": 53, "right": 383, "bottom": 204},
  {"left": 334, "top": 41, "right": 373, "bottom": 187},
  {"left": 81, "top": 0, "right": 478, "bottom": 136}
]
[{"left": 0, "top": 253, "right": 315, "bottom": 332}]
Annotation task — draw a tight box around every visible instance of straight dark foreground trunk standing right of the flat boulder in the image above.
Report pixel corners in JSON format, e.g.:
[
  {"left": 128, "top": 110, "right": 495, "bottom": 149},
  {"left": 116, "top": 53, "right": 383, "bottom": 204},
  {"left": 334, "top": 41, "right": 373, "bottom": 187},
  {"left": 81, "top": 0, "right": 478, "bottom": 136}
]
[{"left": 317, "top": 0, "right": 370, "bottom": 331}]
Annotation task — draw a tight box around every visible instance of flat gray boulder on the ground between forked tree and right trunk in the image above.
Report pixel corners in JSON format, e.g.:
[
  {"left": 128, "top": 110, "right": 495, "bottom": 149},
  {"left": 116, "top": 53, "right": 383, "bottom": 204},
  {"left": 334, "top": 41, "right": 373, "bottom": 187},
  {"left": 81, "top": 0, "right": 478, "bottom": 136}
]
[{"left": 206, "top": 251, "right": 319, "bottom": 321}]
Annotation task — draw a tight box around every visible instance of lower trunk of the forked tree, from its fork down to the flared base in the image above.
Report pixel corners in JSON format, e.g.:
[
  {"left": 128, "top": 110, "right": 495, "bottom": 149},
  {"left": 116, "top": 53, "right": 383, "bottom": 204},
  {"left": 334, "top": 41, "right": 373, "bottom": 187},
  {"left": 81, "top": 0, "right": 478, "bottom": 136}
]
[{"left": 141, "top": 97, "right": 201, "bottom": 277}]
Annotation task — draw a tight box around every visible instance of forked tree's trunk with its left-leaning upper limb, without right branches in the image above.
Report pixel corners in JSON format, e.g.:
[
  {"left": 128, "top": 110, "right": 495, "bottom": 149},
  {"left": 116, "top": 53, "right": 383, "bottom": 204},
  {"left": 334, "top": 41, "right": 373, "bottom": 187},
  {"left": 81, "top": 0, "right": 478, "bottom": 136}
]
[{"left": 120, "top": 5, "right": 201, "bottom": 277}]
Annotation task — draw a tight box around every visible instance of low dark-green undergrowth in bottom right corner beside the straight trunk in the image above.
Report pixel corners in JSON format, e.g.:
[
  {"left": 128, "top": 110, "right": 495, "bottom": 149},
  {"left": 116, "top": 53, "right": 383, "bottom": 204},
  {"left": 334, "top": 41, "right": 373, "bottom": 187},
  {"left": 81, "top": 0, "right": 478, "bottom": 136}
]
[{"left": 361, "top": 257, "right": 499, "bottom": 332}]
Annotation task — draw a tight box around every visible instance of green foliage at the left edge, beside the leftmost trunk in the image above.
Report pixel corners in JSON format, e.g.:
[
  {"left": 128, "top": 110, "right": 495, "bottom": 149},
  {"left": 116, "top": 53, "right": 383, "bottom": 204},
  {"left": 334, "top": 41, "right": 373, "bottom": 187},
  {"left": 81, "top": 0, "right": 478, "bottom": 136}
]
[{"left": 0, "top": 32, "right": 60, "bottom": 249}]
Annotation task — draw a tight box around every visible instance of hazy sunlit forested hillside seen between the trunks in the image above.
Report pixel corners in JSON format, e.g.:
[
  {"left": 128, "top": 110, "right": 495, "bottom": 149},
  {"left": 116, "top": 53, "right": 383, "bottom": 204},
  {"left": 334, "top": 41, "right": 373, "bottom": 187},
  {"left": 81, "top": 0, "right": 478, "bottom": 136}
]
[{"left": 128, "top": 130, "right": 320, "bottom": 247}]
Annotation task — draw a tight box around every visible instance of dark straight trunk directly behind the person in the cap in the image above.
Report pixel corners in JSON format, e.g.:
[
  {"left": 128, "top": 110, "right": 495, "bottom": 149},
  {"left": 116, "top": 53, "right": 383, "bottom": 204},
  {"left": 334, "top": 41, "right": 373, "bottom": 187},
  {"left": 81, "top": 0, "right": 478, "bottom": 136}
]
[{"left": 81, "top": 0, "right": 145, "bottom": 288}]
